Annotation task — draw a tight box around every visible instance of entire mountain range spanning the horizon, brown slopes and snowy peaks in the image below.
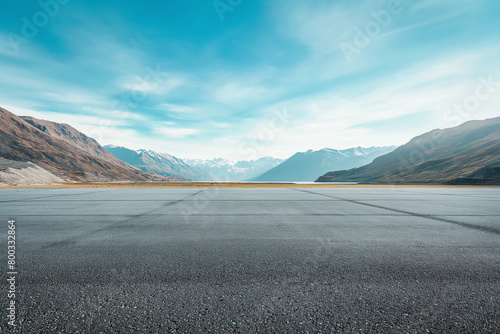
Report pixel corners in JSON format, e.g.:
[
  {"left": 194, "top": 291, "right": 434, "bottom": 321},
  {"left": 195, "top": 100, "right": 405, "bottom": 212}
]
[{"left": 0, "top": 108, "right": 500, "bottom": 185}]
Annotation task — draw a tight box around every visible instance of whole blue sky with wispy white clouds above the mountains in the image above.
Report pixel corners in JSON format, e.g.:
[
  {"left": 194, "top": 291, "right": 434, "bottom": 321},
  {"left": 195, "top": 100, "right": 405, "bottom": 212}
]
[{"left": 0, "top": 0, "right": 500, "bottom": 160}]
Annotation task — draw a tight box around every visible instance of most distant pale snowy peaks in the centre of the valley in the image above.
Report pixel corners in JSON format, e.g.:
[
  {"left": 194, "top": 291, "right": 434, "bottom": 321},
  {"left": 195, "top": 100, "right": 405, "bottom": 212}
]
[{"left": 186, "top": 157, "right": 284, "bottom": 181}]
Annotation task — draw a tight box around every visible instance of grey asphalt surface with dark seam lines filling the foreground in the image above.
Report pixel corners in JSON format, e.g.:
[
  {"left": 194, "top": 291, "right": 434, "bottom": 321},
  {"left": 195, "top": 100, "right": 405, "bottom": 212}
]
[{"left": 0, "top": 187, "right": 500, "bottom": 333}]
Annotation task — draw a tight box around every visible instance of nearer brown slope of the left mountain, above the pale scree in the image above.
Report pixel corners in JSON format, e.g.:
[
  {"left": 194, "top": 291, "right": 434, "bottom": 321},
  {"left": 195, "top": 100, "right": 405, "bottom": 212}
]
[{"left": 0, "top": 108, "right": 176, "bottom": 181}]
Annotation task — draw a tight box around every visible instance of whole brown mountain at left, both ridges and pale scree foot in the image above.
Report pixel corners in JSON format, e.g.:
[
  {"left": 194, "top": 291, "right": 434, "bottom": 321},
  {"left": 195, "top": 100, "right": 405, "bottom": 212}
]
[{"left": 0, "top": 108, "right": 176, "bottom": 183}]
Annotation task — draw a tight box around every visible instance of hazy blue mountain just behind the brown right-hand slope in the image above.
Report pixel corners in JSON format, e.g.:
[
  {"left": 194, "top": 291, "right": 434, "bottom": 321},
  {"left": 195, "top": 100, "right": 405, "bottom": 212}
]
[{"left": 253, "top": 146, "right": 396, "bottom": 182}]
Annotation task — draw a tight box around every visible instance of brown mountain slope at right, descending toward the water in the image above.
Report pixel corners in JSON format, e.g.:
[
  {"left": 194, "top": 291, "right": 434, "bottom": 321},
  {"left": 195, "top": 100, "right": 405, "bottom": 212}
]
[{"left": 317, "top": 117, "right": 500, "bottom": 183}]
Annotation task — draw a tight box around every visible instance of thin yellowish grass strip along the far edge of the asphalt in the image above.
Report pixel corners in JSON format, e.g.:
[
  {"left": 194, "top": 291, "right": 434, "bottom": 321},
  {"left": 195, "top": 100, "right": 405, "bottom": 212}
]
[{"left": 0, "top": 182, "right": 500, "bottom": 189}]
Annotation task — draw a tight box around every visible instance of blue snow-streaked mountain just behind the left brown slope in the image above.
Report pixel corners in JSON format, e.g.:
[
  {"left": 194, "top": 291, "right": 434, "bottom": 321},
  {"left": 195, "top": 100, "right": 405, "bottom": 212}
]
[{"left": 104, "top": 145, "right": 213, "bottom": 181}]
